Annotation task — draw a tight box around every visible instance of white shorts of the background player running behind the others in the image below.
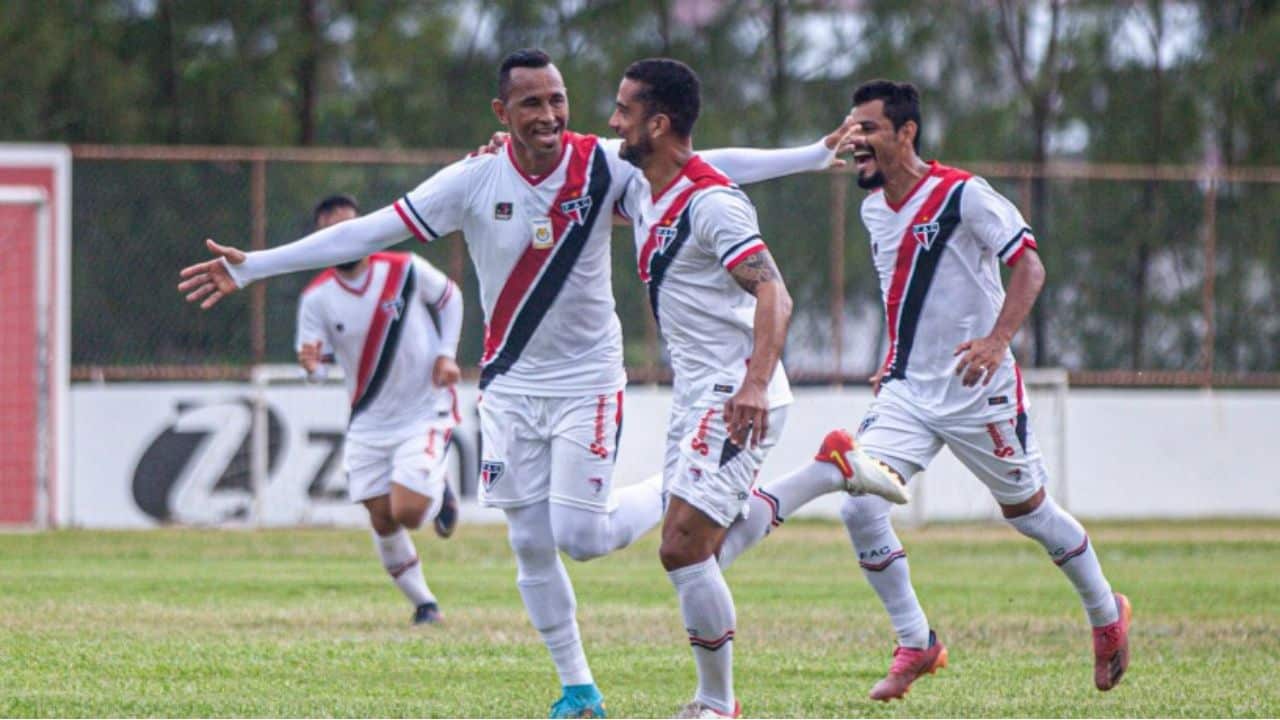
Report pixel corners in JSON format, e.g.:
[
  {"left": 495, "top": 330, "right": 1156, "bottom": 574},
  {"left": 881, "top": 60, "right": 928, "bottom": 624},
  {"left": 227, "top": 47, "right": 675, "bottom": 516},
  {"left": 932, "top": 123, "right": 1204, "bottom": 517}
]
[{"left": 342, "top": 416, "right": 457, "bottom": 502}]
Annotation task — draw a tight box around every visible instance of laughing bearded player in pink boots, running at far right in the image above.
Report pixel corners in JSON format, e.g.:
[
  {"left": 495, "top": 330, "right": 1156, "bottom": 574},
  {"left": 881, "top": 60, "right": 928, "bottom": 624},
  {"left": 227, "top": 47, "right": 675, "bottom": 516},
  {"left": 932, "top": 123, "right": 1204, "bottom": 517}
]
[{"left": 841, "top": 81, "right": 1130, "bottom": 701}]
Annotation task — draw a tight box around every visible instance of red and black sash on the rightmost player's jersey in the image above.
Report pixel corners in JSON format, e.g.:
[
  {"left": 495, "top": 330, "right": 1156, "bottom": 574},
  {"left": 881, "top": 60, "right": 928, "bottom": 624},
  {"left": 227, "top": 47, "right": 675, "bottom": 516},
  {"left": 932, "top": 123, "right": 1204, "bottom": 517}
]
[{"left": 884, "top": 165, "right": 972, "bottom": 380}]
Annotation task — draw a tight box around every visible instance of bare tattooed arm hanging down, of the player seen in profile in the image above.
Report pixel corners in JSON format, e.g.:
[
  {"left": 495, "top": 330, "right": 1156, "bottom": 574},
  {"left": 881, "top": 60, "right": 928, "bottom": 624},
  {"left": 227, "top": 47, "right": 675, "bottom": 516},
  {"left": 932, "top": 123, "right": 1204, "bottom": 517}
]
[{"left": 724, "top": 247, "right": 791, "bottom": 447}]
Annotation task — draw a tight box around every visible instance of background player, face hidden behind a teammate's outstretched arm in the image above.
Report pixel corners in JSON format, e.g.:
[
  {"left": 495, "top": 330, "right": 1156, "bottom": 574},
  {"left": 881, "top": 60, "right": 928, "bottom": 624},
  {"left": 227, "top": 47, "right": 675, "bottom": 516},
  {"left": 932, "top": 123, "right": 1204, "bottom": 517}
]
[{"left": 297, "top": 195, "right": 462, "bottom": 624}]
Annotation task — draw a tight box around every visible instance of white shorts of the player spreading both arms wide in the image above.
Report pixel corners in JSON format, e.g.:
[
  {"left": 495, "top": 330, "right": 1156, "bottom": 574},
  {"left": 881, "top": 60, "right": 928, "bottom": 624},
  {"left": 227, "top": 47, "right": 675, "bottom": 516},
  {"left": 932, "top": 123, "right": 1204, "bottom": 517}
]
[{"left": 480, "top": 391, "right": 622, "bottom": 512}]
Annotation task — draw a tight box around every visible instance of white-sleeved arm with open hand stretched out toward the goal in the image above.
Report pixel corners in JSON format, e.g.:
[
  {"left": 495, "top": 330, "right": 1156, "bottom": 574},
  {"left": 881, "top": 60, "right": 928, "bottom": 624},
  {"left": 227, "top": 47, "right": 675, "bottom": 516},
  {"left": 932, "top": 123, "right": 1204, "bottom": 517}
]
[{"left": 178, "top": 206, "right": 410, "bottom": 310}]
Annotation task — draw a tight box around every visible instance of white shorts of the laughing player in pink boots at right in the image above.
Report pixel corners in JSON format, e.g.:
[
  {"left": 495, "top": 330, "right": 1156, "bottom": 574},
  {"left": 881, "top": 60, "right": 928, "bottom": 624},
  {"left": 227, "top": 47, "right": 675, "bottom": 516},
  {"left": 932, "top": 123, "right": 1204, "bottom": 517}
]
[{"left": 858, "top": 392, "right": 1047, "bottom": 505}]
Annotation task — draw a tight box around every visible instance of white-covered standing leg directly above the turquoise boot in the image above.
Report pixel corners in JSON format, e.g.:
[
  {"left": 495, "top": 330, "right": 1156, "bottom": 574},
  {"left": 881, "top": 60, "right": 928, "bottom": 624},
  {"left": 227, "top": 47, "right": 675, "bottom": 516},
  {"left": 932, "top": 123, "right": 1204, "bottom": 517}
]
[{"left": 507, "top": 502, "right": 595, "bottom": 685}]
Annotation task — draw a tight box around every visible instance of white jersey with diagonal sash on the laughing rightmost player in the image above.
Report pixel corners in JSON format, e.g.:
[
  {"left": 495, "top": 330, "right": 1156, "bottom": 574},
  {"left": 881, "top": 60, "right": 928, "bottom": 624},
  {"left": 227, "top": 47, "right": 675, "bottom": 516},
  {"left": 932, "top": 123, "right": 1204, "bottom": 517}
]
[{"left": 861, "top": 163, "right": 1036, "bottom": 419}]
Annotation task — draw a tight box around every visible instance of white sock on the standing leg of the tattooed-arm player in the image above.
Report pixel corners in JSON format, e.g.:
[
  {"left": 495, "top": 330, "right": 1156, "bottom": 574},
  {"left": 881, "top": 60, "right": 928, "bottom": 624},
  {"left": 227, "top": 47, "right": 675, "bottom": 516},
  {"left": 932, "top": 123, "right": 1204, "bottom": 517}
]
[{"left": 667, "top": 557, "right": 737, "bottom": 714}]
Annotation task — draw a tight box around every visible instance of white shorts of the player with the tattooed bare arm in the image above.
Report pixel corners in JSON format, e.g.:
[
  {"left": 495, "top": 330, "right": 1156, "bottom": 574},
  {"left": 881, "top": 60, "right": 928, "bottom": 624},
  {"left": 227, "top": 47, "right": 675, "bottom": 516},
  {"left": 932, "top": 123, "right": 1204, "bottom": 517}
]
[{"left": 662, "top": 389, "right": 787, "bottom": 528}]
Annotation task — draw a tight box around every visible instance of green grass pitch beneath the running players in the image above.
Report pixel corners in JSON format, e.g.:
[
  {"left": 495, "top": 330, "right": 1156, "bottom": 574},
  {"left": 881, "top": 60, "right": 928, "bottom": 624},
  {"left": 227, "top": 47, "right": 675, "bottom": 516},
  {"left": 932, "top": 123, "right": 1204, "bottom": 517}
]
[{"left": 0, "top": 521, "right": 1280, "bottom": 717}]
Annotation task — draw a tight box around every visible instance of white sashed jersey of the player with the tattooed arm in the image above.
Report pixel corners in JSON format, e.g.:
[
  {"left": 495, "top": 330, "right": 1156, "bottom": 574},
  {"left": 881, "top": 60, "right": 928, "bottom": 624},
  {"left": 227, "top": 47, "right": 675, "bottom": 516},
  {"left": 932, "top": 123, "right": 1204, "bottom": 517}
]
[{"left": 618, "top": 155, "right": 791, "bottom": 407}]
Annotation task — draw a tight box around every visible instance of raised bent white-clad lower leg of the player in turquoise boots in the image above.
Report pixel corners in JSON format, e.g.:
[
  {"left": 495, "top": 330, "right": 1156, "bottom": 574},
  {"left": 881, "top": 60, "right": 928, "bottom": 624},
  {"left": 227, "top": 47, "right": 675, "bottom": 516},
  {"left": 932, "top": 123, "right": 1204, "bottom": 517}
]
[{"left": 550, "top": 475, "right": 662, "bottom": 560}]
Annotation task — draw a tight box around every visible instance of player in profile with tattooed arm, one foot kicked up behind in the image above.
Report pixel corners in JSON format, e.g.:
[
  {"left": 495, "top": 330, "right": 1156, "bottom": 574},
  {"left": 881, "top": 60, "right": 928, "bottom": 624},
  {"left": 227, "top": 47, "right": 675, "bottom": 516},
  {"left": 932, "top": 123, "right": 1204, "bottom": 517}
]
[{"left": 609, "top": 59, "right": 906, "bottom": 717}]
